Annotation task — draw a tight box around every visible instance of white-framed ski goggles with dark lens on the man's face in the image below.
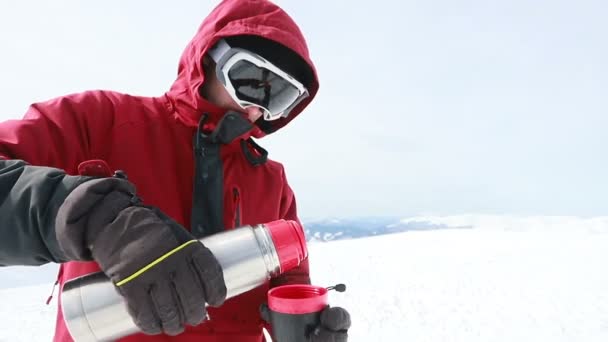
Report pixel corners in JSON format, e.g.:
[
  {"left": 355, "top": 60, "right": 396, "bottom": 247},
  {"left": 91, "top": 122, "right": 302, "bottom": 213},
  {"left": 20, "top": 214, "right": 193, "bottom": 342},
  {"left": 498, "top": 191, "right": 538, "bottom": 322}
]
[{"left": 209, "top": 39, "right": 308, "bottom": 121}]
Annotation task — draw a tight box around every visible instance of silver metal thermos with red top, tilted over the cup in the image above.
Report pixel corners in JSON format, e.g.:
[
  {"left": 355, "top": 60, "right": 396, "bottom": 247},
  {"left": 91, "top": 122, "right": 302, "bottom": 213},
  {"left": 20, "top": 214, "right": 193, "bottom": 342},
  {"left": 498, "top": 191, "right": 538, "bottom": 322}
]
[{"left": 61, "top": 220, "right": 308, "bottom": 342}]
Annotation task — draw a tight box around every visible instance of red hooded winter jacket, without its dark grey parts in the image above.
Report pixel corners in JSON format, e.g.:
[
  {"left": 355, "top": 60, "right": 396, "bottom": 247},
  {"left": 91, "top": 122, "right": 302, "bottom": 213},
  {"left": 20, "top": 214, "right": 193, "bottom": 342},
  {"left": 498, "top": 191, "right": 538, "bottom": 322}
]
[{"left": 0, "top": 0, "right": 318, "bottom": 342}]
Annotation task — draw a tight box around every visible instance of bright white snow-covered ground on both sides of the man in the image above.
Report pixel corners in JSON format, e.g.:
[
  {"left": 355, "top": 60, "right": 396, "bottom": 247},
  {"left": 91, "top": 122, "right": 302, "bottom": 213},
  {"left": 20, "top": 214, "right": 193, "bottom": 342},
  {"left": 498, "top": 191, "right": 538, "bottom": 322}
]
[{"left": 0, "top": 217, "right": 608, "bottom": 342}]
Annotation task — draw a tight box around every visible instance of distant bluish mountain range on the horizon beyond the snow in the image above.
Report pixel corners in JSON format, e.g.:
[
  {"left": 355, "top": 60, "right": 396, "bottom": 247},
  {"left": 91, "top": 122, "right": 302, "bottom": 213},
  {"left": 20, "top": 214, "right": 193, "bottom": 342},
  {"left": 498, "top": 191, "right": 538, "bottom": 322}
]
[{"left": 303, "top": 217, "right": 472, "bottom": 242}]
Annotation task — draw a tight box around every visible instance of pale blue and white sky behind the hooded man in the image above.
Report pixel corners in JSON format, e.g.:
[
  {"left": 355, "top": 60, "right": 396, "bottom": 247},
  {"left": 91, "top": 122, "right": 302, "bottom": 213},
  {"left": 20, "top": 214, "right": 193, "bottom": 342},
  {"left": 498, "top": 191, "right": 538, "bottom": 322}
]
[{"left": 0, "top": 0, "right": 608, "bottom": 217}]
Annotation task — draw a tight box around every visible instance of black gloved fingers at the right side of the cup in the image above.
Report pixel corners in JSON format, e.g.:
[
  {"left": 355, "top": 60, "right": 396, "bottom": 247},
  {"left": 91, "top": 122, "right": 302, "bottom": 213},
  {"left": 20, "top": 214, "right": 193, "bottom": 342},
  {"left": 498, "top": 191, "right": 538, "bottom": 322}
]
[{"left": 310, "top": 307, "right": 350, "bottom": 342}]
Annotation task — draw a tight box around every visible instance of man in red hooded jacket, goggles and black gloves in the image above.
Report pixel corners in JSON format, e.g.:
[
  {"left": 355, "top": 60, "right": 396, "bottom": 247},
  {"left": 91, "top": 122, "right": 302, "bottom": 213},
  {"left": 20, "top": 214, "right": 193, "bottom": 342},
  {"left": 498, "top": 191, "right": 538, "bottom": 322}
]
[{"left": 0, "top": 0, "right": 350, "bottom": 342}]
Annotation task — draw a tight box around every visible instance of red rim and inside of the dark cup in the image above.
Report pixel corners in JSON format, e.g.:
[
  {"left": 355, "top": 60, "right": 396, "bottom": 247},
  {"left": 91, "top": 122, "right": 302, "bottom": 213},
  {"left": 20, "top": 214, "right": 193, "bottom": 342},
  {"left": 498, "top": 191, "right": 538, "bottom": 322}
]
[{"left": 268, "top": 284, "right": 327, "bottom": 314}]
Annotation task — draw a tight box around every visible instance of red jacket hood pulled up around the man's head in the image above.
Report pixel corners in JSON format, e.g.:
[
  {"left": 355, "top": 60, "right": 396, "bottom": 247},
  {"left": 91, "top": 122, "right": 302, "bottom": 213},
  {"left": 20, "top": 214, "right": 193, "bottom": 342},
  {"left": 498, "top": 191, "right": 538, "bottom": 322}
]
[{"left": 166, "top": 0, "right": 319, "bottom": 137}]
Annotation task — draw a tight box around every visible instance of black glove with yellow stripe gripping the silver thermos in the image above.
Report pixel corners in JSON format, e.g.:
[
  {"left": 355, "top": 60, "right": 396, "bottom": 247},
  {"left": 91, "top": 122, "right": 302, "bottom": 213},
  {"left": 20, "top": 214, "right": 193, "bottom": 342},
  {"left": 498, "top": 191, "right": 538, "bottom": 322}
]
[{"left": 56, "top": 178, "right": 226, "bottom": 335}]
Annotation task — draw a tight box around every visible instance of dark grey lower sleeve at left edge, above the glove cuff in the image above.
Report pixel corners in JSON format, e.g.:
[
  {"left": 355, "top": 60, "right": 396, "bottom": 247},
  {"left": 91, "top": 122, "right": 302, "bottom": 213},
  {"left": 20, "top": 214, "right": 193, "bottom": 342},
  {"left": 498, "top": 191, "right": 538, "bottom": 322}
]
[{"left": 0, "top": 160, "right": 88, "bottom": 266}]
